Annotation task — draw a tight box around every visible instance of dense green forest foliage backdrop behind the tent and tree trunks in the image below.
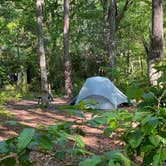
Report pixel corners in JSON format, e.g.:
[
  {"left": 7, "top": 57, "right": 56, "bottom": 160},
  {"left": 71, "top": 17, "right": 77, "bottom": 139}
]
[{"left": 0, "top": 0, "right": 166, "bottom": 95}]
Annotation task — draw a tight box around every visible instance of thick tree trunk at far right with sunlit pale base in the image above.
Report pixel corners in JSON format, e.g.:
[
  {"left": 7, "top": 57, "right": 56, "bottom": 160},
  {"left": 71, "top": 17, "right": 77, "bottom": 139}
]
[{"left": 148, "top": 0, "right": 163, "bottom": 85}]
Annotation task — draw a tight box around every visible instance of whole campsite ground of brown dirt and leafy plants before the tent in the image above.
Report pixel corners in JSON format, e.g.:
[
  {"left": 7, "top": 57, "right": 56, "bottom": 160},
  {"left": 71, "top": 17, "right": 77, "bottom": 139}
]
[{"left": 0, "top": 88, "right": 166, "bottom": 166}]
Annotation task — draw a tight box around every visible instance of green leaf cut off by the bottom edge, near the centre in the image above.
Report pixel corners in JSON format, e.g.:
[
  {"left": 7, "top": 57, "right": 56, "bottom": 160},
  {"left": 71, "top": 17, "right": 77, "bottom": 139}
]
[{"left": 79, "top": 156, "right": 101, "bottom": 166}]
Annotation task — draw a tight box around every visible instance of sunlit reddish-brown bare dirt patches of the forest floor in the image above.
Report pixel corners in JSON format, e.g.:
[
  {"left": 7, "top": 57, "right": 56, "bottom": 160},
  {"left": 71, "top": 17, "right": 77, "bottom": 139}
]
[{"left": 0, "top": 98, "right": 135, "bottom": 166}]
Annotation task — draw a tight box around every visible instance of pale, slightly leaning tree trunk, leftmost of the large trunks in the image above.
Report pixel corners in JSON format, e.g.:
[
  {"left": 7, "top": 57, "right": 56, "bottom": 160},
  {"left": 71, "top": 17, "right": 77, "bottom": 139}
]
[{"left": 36, "top": 0, "right": 49, "bottom": 107}]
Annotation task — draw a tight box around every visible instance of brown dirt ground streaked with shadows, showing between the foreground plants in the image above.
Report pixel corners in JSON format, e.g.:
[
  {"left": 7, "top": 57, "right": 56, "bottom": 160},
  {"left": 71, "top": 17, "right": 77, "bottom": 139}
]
[{"left": 0, "top": 98, "right": 130, "bottom": 165}]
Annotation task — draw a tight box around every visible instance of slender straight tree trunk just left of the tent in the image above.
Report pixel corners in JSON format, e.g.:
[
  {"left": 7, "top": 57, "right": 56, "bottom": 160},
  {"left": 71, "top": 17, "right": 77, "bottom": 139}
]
[{"left": 63, "top": 0, "right": 72, "bottom": 98}]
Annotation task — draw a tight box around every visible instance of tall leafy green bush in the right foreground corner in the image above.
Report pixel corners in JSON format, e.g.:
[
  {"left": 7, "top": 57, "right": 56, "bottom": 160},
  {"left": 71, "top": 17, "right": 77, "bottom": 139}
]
[{"left": 123, "top": 88, "right": 166, "bottom": 165}]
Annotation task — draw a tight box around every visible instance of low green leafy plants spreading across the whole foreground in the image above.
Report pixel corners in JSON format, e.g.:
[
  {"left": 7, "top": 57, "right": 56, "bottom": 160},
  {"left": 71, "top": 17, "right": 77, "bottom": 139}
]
[{"left": 0, "top": 85, "right": 166, "bottom": 166}]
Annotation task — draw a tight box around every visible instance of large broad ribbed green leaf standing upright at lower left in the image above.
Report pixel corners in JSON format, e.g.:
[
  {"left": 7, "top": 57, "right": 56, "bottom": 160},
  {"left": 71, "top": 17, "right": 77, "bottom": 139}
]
[{"left": 17, "top": 128, "right": 35, "bottom": 150}]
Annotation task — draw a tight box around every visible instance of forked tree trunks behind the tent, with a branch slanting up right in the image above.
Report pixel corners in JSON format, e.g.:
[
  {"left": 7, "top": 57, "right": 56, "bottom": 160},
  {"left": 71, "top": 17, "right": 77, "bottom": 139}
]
[{"left": 100, "top": 0, "right": 133, "bottom": 79}]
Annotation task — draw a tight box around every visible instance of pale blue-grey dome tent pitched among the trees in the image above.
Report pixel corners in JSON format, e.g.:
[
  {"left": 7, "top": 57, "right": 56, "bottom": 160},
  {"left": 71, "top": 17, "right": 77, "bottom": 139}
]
[{"left": 75, "top": 76, "right": 128, "bottom": 109}]
